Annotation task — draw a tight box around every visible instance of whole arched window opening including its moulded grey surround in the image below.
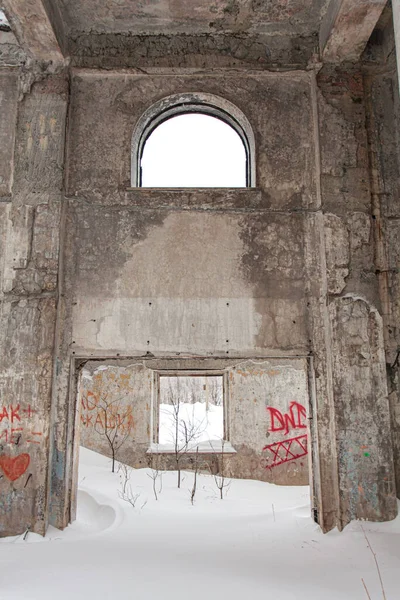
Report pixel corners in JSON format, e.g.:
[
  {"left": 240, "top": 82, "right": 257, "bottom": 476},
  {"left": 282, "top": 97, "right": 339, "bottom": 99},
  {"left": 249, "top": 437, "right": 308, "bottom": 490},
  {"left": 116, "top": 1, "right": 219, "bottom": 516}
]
[{"left": 131, "top": 92, "right": 255, "bottom": 188}]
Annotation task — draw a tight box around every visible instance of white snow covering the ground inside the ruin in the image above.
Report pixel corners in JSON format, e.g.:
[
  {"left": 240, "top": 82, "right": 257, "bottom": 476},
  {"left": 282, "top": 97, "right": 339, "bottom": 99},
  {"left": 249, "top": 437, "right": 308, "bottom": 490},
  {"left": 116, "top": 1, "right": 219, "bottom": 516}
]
[{"left": 0, "top": 449, "right": 400, "bottom": 600}]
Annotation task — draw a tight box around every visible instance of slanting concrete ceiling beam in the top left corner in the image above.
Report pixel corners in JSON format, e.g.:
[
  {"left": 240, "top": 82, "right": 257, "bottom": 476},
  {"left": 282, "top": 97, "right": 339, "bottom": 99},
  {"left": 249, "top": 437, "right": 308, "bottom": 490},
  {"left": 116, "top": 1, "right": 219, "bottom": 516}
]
[{"left": 2, "top": 0, "right": 64, "bottom": 63}]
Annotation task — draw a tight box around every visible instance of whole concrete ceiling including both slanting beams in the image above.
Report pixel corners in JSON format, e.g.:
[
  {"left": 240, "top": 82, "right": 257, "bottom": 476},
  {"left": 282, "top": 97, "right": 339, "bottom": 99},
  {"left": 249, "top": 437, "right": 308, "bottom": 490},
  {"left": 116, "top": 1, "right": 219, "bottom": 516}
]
[{"left": 0, "top": 0, "right": 387, "bottom": 69}]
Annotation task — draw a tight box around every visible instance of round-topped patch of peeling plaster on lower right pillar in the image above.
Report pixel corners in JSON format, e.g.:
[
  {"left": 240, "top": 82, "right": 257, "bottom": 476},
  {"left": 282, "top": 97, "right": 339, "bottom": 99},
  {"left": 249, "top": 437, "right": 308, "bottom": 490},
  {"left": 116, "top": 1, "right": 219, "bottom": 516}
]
[{"left": 330, "top": 296, "right": 397, "bottom": 524}]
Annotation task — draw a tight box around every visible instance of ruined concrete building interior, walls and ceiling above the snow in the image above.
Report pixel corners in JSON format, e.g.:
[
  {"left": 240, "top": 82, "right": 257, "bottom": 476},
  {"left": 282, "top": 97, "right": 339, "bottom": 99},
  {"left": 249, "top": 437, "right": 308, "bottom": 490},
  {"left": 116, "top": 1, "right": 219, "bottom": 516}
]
[{"left": 0, "top": 0, "right": 400, "bottom": 536}]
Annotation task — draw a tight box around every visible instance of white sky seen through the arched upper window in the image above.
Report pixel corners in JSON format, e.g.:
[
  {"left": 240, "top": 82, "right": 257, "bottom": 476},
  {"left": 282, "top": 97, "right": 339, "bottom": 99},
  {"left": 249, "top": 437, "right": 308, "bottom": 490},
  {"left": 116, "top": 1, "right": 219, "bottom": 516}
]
[{"left": 141, "top": 113, "right": 246, "bottom": 188}]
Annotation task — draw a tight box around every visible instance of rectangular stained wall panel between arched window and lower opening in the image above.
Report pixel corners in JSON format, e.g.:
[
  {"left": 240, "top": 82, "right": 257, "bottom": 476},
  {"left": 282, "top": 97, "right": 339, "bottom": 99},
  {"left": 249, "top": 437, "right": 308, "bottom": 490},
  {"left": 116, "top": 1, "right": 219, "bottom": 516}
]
[{"left": 67, "top": 197, "right": 306, "bottom": 355}]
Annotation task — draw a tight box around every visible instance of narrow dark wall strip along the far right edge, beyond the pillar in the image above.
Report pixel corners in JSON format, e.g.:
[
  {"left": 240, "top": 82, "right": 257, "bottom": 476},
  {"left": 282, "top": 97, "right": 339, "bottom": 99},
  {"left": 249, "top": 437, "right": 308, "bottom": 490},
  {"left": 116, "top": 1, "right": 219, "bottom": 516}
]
[{"left": 364, "top": 9, "right": 400, "bottom": 497}]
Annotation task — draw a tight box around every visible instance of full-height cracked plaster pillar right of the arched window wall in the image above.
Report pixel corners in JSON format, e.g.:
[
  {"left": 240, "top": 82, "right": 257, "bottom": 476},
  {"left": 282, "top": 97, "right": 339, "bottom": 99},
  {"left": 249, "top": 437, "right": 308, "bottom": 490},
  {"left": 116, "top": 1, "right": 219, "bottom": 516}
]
[{"left": 317, "top": 67, "right": 396, "bottom": 527}]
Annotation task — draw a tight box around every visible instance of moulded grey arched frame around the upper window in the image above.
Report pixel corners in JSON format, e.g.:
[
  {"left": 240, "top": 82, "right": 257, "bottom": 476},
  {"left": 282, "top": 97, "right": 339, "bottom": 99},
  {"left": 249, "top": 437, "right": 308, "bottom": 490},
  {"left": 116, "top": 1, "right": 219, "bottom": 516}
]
[{"left": 131, "top": 92, "right": 256, "bottom": 187}]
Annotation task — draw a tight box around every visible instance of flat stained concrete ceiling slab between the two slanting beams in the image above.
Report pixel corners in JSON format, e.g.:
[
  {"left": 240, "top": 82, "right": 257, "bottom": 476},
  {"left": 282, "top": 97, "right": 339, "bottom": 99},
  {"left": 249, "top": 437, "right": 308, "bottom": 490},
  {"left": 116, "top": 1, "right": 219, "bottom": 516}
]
[{"left": 54, "top": 0, "right": 328, "bottom": 36}]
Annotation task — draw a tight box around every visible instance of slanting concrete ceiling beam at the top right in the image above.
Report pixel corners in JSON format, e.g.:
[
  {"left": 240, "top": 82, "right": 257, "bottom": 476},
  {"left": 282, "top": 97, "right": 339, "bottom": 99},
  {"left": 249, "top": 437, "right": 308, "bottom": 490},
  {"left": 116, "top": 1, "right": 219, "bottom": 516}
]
[{"left": 319, "top": 0, "right": 386, "bottom": 62}]
